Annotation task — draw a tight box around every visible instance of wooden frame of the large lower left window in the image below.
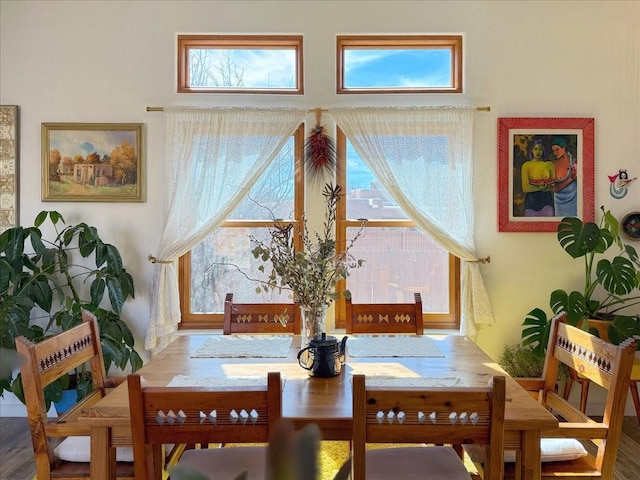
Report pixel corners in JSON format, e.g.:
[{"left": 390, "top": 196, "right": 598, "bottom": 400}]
[{"left": 178, "top": 123, "right": 305, "bottom": 330}]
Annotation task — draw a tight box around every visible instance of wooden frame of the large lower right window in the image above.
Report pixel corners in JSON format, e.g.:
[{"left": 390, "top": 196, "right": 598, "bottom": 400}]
[{"left": 335, "top": 127, "right": 461, "bottom": 330}]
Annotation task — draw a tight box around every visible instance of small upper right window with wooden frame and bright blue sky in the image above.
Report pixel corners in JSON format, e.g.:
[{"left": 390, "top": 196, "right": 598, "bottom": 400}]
[{"left": 336, "top": 35, "right": 462, "bottom": 93}]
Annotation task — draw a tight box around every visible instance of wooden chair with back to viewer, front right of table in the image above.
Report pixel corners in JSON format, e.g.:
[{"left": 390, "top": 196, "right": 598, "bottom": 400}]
[{"left": 352, "top": 375, "right": 505, "bottom": 480}]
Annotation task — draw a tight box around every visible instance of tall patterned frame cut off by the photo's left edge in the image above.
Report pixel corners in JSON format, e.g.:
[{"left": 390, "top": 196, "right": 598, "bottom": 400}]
[{"left": 0, "top": 105, "right": 20, "bottom": 233}]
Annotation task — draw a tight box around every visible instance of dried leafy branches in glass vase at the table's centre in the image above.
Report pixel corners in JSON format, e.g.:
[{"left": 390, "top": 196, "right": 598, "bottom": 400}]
[{"left": 251, "top": 184, "right": 365, "bottom": 346}]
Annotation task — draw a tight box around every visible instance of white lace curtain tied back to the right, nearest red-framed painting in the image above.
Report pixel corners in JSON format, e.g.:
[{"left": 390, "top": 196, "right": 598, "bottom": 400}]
[{"left": 330, "top": 107, "right": 495, "bottom": 338}]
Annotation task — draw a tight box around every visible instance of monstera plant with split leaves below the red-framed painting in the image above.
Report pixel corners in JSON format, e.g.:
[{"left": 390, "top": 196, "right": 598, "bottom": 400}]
[{"left": 522, "top": 207, "right": 640, "bottom": 357}]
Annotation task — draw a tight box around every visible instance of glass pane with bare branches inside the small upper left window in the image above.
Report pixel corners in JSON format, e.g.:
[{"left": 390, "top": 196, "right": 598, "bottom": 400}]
[{"left": 189, "top": 48, "right": 297, "bottom": 89}]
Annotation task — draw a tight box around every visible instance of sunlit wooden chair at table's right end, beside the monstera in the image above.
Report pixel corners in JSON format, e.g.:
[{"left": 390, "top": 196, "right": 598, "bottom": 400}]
[{"left": 506, "top": 312, "right": 636, "bottom": 479}]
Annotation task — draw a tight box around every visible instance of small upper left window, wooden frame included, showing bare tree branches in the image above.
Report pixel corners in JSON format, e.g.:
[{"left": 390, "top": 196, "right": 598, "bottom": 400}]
[{"left": 178, "top": 35, "right": 304, "bottom": 94}]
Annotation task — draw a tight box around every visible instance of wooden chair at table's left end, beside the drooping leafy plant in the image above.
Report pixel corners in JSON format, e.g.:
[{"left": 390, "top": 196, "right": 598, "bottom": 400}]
[{"left": 16, "top": 312, "right": 134, "bottom": 480}]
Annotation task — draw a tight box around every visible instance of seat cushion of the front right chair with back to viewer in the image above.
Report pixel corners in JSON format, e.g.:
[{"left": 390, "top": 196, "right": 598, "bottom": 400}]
[{"left": 366, "top": 447, "right": 469, "bottom": 480}]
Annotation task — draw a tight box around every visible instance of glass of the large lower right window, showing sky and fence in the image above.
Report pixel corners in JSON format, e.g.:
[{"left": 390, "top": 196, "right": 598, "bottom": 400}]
[{"left": 346, "top": 137, "right": 451, "bottom": 314}]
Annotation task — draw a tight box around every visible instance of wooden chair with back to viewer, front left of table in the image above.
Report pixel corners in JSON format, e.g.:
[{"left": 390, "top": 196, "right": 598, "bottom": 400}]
[{"left": 127, "top": 372, "right": 282, "bottom": 480}]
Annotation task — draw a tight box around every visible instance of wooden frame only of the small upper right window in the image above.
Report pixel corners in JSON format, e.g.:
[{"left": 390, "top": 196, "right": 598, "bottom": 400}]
[{"left": 336, "top": 35, "right": 462, "bottom": 94}]
